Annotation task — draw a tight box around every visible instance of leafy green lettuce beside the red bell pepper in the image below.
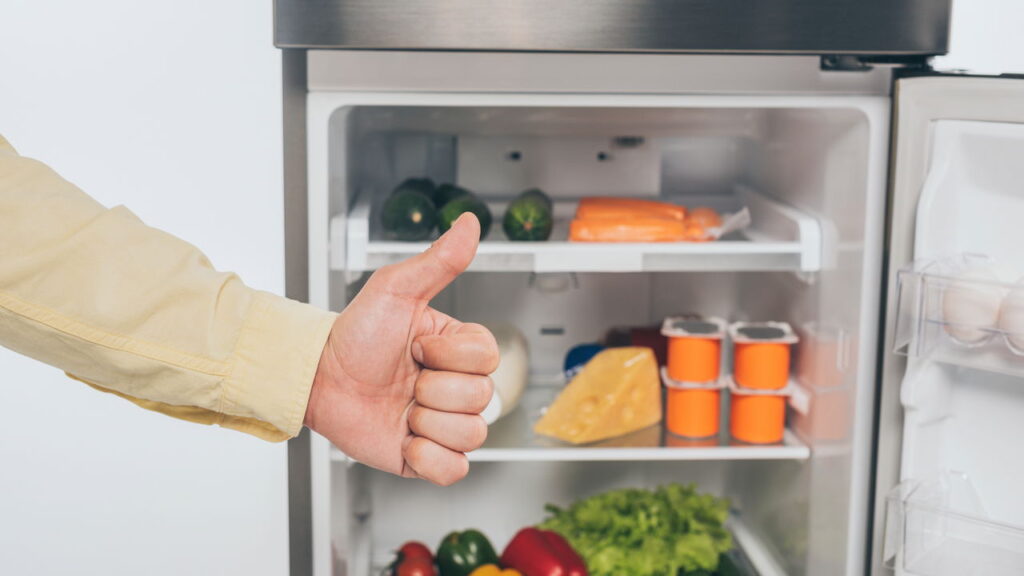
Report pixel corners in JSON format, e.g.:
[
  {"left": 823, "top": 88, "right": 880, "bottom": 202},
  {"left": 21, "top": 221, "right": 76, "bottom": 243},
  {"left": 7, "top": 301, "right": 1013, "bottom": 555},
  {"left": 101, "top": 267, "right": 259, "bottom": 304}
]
[{"left": 540, "top": 484, "right": 732, "bottom": 576}]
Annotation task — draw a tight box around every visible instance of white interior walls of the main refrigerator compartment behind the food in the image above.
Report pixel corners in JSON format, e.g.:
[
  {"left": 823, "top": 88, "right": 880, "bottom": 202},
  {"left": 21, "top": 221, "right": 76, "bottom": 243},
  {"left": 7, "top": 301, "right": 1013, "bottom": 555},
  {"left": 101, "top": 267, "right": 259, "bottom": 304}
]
[{"left": 309, "top": 93, "right": 888, "bottom": 575}]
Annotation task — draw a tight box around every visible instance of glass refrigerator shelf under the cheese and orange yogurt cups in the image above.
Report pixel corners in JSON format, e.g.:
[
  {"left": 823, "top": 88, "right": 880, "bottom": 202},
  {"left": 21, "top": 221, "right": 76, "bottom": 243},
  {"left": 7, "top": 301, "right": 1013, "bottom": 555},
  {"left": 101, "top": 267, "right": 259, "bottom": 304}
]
[{"left": 331, "top": 385, "right": 811, "bottom": 462}]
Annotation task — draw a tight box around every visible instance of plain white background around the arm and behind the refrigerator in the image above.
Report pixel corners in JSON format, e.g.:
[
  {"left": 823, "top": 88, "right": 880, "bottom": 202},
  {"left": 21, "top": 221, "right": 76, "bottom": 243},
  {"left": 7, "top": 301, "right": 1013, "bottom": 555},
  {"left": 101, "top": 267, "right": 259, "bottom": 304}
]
[{"left": 0, "top": 0, "right": 1024, "bottom": 576}]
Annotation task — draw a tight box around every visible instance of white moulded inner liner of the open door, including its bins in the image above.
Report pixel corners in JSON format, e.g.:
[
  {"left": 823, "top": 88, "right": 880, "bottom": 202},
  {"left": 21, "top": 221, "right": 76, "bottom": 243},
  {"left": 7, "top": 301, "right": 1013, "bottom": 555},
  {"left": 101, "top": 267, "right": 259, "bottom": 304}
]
[{"left": 889, "top": 120, "right": 1024, "bottom": 576}]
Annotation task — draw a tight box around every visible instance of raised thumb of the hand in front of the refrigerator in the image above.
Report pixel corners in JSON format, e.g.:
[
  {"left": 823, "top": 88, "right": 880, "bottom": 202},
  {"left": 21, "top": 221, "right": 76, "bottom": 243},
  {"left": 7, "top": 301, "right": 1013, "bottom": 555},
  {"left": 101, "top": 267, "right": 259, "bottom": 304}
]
[{"left": 385, "top": 212, "right": 480, "bottom": 300}]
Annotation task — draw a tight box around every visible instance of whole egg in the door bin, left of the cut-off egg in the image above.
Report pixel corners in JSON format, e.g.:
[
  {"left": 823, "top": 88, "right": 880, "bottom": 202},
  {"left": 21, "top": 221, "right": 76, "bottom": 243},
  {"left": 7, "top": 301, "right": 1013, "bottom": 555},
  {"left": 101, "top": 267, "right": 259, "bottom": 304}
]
[{"left": 942, "top": 265, "right": 1006, "bottom": 345}]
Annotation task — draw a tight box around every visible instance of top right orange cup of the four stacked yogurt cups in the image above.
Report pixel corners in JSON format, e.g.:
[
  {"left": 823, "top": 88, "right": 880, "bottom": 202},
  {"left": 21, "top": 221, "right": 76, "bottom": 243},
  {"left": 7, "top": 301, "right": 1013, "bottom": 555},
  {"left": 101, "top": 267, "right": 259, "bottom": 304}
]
[{"left": 729, "top": 322, "right": 799, "bottom": 389}]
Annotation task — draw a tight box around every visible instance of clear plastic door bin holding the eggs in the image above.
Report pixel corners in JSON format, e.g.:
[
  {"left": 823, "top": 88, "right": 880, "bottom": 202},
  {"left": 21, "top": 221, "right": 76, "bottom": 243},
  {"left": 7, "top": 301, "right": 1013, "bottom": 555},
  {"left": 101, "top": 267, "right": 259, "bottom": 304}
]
[{"left": 894, "top": 254, "right": 1024, "bottom": 376}]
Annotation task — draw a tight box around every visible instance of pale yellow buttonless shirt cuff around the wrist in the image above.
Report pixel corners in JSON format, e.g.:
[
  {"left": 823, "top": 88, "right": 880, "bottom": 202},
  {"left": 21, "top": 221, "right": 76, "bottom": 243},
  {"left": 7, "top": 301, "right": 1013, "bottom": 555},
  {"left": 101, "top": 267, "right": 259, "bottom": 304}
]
[{"left": 218, "top": 292, "right": 338, "bottom": 441}]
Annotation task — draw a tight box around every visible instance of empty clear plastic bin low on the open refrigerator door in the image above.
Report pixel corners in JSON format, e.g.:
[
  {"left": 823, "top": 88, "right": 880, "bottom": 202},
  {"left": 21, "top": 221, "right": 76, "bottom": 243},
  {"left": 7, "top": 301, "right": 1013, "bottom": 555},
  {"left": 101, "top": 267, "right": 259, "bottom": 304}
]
[{"left": 884, "top": 472, "right": 1024, "bottom": 576}]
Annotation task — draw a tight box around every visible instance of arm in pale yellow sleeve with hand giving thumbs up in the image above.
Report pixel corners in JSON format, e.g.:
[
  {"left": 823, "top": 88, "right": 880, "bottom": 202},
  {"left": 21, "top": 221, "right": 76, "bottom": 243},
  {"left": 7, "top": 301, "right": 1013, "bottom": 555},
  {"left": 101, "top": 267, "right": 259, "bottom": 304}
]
[{"left": 0, "top": 133, "right": 498, "bottom": 484}]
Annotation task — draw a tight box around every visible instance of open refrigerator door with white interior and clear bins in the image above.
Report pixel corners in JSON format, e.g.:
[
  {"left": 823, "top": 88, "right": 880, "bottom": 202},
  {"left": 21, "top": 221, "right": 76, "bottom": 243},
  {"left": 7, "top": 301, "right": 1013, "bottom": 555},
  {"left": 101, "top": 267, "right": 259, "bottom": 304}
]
[{"left": 873, "top": 77, "right": 1024, "bottom": 576}]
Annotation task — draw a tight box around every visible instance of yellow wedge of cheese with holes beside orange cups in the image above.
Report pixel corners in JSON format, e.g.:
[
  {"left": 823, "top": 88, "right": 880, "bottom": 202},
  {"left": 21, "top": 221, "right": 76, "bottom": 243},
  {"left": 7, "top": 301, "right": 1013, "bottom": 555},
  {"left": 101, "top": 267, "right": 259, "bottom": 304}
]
[{"left": 534, "top": 347, "right": 662, "bottom": 444}]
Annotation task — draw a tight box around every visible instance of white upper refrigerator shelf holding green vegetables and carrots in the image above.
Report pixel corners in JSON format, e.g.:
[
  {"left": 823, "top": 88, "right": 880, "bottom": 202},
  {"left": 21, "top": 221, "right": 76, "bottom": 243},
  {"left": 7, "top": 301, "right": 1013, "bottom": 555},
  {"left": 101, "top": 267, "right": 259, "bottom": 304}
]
[{"left": 331, "top": 187, "right": 822, "bottom": 273}]
